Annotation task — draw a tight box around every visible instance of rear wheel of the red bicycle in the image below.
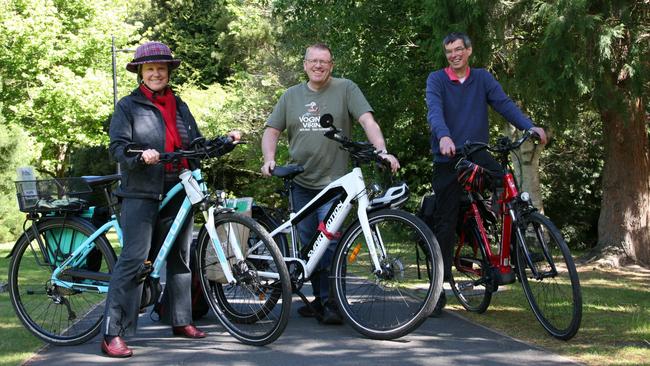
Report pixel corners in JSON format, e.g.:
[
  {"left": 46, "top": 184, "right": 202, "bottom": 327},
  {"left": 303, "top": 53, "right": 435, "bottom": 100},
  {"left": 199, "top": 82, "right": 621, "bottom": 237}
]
[{"left": 449, "top": 220, "right": 492, "bottom": 314}]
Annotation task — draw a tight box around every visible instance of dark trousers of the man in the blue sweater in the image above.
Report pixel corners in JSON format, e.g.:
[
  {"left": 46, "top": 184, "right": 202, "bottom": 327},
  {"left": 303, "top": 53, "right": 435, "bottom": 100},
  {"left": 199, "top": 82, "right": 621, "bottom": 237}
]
[{"left": 429, "top": 151, "right": 503, "bottom": 281}]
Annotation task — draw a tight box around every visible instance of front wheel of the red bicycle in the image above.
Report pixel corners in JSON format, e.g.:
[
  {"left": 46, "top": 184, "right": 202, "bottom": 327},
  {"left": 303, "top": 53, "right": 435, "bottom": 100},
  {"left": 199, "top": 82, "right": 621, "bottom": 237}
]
[{"left": 516, "top": 212, "right": 582, "bottom": 340}]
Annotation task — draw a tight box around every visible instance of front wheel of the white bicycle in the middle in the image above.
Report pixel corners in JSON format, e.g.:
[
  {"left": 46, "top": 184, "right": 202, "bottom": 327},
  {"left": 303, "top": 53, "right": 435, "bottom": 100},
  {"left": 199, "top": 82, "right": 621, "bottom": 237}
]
[{"left": 332, "top": 209, "right": 442, "bottom": 339}]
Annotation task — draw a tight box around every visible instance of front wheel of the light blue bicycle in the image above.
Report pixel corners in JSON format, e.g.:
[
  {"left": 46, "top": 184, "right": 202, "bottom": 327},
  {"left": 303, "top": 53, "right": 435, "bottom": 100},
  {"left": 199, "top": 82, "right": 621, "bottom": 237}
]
[{"left": 197, "top": 213, "right": 291, "bottom": 346}]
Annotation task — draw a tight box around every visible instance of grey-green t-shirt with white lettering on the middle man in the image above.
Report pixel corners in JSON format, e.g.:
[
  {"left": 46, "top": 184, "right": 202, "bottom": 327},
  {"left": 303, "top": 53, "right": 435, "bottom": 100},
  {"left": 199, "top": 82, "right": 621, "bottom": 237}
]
[{"left": 266, "top": 78, "right": 373, "bottom": 189}]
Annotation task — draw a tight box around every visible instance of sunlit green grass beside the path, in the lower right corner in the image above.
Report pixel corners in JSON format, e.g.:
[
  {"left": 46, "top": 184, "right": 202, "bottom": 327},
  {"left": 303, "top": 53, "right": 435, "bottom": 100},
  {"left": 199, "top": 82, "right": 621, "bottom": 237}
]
[{"left": 449, "top": 265, "right": 650, "bottom": 365}]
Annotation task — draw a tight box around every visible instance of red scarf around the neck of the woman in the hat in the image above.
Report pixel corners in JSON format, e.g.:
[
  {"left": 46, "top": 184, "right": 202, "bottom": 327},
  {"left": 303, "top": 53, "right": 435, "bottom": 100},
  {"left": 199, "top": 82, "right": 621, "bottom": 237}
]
[{"left": 140, "top": 84, "right": 189, "bottom": 171}]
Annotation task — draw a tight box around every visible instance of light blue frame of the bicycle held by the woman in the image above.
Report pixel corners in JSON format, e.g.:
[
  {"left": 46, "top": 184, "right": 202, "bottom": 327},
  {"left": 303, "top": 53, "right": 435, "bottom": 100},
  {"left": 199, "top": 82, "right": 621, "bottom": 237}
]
[{"left": 47, "top": 169, "right": 246, "bottom": 293}]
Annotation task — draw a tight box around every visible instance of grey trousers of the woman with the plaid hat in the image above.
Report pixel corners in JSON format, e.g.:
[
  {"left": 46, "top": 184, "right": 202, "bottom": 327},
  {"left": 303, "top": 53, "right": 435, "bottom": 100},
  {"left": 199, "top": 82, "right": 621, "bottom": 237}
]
[{"left": 103, "top": 194, "right": 194, "bottom": 336}]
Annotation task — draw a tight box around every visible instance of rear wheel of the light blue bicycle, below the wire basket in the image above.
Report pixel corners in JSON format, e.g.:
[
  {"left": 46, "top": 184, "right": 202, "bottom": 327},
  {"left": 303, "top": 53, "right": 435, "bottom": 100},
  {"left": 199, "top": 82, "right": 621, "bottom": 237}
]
[{"left": 9, "top": 218, "right": 116, "bottom": 345}]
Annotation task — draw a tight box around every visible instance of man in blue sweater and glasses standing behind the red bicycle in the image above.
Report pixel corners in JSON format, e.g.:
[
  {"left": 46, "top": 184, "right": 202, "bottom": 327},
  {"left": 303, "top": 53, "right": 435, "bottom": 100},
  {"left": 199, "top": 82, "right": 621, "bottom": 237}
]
[{"left": 426, "top": 33, "right": 546, "bottom": 315}]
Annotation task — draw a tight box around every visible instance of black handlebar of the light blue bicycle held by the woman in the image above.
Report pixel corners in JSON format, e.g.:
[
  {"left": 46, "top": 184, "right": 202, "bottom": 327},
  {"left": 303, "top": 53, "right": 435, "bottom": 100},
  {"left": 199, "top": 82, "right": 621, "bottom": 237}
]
[{"left": 124, "top": 136, "right": 240, "bottom": 164}]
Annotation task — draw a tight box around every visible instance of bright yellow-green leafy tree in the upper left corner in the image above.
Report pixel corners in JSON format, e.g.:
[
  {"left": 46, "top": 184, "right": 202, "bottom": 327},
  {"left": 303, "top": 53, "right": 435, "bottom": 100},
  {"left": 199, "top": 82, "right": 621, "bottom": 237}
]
[{"left": 0, "top": 0, "right": 135, "bottom": 176}]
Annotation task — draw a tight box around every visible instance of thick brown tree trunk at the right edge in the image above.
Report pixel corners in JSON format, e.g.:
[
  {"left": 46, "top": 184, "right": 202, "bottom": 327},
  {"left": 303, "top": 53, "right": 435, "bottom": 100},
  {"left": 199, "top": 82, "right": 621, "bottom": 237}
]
[{"left": 592, "top": 94, "right": 650, "bottom": 266}]
